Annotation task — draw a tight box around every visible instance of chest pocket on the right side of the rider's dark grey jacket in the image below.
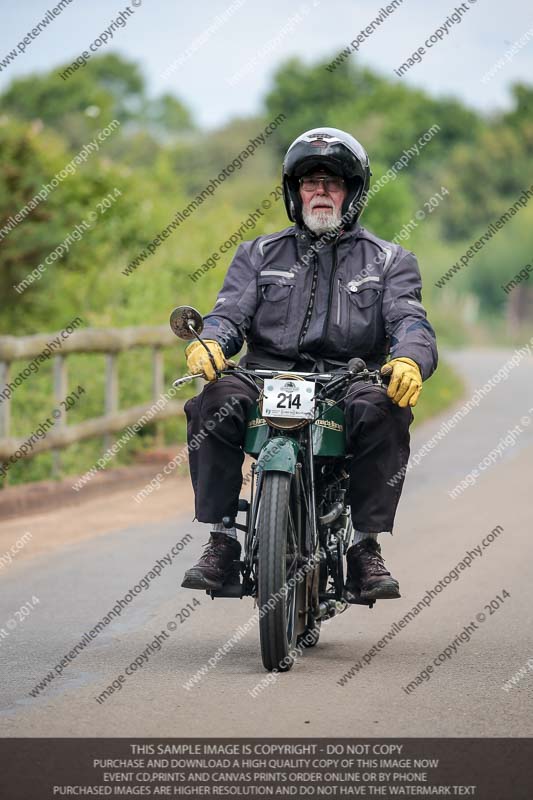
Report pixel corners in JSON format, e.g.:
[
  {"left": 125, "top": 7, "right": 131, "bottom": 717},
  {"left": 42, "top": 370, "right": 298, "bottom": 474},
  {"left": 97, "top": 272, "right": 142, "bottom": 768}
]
[{"left": 336, "top": 277, "right": 383, "bottom": 346}]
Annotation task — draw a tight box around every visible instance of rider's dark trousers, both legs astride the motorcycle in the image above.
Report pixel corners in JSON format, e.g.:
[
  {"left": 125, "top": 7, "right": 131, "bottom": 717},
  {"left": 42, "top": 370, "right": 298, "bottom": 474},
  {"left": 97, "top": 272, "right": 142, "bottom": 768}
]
[{"left": 185, "top": 375, "right": 413, "bottom": 533}]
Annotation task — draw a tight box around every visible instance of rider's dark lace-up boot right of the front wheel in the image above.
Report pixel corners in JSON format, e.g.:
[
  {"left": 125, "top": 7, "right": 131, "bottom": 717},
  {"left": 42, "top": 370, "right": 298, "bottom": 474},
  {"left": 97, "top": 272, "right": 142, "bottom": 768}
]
[{"left": 346, "top": 538, "right": 401, "bottom": 601}]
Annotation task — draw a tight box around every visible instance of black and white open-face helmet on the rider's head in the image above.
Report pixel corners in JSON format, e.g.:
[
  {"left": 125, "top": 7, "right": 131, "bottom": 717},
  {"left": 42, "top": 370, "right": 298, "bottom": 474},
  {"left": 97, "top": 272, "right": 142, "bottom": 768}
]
[{"left": 282, "top": 128, "right": 372, "bottom": 230}]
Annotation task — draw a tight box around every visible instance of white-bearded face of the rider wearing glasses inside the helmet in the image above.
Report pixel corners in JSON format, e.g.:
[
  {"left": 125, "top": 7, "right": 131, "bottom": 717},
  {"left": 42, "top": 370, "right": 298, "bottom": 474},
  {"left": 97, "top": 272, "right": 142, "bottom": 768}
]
[{"left": 300, "top": 167, "right": 347, "bottom": 236}]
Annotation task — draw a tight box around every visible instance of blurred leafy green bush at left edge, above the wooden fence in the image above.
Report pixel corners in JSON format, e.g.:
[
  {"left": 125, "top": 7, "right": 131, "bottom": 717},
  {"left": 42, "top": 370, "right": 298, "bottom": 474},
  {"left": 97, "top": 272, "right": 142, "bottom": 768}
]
[{"left": 0, "top": 117, "right": 155, "bottom": 333}]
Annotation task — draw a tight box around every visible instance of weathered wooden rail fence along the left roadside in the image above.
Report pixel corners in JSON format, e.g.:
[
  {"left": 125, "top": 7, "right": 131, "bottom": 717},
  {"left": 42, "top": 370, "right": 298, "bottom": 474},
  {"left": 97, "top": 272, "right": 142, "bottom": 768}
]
[{"left": 0, "top": 325, "right": 193, "bottom": 482}]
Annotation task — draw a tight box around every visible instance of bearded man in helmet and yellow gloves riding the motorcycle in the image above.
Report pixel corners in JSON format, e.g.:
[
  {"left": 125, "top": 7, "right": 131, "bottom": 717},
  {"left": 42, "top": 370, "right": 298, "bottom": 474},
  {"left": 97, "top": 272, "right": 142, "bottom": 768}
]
[{"left": 182, "top": 128, "right": 437, "bottom": 601}]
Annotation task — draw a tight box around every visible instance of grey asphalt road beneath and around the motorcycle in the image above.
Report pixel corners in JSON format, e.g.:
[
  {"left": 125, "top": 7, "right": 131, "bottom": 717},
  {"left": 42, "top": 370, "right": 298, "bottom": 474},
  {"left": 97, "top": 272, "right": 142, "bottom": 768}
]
[{"left": 0, "top": 350, "right": 533, "bottom": 737}]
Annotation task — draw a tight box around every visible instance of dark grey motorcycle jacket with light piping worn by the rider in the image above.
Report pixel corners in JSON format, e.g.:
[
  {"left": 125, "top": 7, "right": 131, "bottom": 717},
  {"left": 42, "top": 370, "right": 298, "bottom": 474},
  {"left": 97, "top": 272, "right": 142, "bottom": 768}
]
[{"left": 203, "top": 225, "right": 438, "bottom": 380}]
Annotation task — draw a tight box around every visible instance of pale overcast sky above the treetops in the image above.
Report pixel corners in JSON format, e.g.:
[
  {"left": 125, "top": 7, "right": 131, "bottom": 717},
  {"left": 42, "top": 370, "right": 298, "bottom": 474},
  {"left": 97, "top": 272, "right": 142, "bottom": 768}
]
[{"left": 0, "top": 0, "right": 533, "bottom": 127}]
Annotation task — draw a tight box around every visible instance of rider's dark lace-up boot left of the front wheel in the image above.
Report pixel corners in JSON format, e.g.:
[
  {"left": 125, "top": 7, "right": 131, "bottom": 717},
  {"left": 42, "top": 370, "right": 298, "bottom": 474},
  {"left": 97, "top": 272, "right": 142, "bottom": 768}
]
[{"left": 181, "top": 531, "right": 241, "bottom": 590}]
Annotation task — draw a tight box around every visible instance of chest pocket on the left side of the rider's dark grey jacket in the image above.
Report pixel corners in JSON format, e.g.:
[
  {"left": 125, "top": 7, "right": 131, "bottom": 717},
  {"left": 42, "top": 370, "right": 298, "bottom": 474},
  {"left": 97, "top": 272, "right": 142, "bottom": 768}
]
[{"left": 255, "top": 269, "right": 296, "bottom": 344}]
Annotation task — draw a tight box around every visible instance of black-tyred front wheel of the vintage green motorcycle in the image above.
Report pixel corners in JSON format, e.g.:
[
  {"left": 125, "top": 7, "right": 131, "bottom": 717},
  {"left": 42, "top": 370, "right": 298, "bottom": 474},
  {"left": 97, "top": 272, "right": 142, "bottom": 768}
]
[{"left": 257, "top": 471, "right": 299, "bottom": 672}]
